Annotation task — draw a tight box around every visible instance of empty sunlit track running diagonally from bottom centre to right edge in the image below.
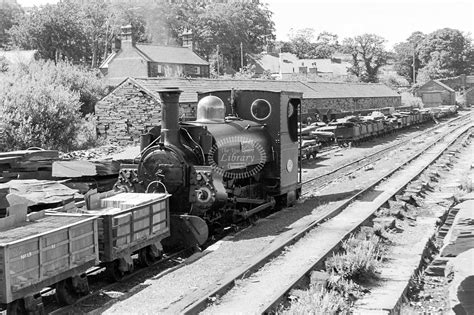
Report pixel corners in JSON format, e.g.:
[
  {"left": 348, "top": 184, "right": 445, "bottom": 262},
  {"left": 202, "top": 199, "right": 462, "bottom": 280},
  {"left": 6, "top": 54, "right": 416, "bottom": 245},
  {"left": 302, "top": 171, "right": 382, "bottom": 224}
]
[{"left": 182, "top": 115, "right": 472, "bottom": 314}]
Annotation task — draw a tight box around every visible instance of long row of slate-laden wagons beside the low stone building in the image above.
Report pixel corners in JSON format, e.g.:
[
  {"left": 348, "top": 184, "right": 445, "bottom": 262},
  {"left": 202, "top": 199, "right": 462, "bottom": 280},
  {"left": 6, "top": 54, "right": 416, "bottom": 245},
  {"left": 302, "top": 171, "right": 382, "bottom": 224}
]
[{"left": 300, "top": 106, "right": 457, "bottom": 159}]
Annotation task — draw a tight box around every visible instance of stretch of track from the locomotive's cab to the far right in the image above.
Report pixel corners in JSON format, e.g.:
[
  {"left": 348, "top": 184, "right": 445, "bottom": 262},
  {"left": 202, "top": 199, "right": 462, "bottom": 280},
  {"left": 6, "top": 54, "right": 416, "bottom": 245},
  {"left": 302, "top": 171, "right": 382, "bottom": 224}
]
[{"left": 301, "top": 114, "right": 470, "bottom": 196}]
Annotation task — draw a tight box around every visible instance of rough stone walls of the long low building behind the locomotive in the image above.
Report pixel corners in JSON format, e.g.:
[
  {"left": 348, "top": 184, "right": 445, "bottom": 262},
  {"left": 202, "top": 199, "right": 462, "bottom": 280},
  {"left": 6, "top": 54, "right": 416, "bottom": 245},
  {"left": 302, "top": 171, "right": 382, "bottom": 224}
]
[{"left": 95, "top": 80, "right": 401, "bottom": 144}]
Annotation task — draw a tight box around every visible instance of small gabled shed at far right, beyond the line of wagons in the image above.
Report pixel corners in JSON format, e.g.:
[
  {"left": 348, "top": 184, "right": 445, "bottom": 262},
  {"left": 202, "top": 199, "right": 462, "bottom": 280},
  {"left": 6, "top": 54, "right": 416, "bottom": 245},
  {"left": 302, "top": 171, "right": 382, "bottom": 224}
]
[{"left": 416, "top": 80, "right": 456, "bottom": 107}]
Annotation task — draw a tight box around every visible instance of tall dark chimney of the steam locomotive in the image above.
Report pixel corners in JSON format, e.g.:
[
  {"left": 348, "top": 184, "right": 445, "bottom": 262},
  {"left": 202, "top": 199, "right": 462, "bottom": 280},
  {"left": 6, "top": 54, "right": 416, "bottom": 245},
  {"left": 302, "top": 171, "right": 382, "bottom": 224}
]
[{"left": 158, "top": 87, "right": 183, "bottom": 146}]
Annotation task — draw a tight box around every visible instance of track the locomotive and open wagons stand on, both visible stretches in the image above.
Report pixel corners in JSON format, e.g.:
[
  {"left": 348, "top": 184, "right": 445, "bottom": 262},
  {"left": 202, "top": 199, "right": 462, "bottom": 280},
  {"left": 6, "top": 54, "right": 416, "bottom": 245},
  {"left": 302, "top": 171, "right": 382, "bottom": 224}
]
[{"left": 39, "top": 115, "right": 469, "bottom": 314}]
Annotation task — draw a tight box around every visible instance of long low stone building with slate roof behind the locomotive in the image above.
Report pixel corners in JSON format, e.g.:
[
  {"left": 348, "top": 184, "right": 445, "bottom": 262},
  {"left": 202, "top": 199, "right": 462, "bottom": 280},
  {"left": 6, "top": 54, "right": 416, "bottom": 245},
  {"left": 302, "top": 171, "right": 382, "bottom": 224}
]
[{"left": 95, "top": 78, "right": 401, "bottom": 143}]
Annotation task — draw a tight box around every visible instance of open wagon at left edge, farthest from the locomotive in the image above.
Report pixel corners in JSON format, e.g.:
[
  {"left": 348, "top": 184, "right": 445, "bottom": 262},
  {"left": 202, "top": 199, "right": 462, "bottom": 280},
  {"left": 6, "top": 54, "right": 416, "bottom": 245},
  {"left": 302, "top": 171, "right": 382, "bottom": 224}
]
[{"left": 0, "top": 208, "right": 98, "bottom": 314}]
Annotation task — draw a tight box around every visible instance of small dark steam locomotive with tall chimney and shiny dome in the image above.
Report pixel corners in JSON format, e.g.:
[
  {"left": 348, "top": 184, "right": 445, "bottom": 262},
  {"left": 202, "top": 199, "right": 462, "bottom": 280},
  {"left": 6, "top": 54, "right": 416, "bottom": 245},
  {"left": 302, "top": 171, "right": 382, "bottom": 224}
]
[{"left": 116, "top": 88, "right": 302, "bottom": 244}]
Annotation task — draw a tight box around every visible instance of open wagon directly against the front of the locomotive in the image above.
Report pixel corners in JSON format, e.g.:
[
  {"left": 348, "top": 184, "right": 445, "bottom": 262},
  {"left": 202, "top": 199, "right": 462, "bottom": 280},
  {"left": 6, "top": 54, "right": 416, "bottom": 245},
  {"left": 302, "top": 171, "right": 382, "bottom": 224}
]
[{"left": 82, "top": 193, "right": 170, "bottom": 280}]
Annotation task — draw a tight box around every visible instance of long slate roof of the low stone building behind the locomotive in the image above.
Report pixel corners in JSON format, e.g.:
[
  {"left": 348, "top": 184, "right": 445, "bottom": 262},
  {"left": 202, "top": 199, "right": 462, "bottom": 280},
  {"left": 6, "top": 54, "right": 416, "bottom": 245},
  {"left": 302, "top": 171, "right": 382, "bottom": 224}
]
[{"left": 117, "top": 78, "right": 400, "bottom": 103}]
